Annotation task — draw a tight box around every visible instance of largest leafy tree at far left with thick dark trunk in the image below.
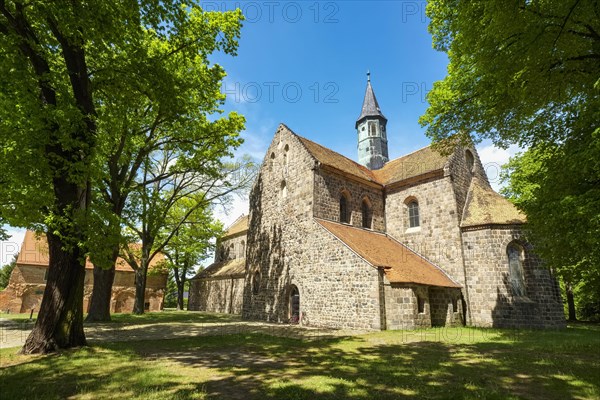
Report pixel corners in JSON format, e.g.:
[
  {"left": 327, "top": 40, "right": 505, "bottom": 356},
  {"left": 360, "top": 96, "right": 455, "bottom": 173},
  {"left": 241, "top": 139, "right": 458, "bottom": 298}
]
[{"left": 0, "top": 0, "right": 244, "bottom": 353}]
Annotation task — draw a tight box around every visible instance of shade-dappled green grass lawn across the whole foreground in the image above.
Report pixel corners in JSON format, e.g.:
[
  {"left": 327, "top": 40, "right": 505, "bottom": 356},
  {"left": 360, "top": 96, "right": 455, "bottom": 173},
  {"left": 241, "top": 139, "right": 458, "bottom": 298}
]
[{"left": 0, "top": 325, "right": 600, "bottom": 400}]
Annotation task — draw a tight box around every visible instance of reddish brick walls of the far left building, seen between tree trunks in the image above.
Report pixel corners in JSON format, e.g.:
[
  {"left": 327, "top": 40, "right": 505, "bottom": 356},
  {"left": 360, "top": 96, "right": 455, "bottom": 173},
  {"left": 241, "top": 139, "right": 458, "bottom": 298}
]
[{"left": 0, "top": 265, "right": 167, "bottom": 313}]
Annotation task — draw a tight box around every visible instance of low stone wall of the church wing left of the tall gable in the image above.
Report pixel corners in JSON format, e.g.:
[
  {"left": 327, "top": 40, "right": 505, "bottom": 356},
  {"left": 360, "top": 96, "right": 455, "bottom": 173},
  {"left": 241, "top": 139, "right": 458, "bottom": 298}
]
[{"left": 188, "top": 277, "right": 244, "bottom": 314}]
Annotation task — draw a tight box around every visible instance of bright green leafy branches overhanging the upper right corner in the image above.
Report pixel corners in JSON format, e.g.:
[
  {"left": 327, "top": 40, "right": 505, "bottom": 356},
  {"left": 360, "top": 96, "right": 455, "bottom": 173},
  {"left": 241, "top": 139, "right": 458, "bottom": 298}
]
[{"left": 420, "top": 0, "right": 600, "bottom": 147}]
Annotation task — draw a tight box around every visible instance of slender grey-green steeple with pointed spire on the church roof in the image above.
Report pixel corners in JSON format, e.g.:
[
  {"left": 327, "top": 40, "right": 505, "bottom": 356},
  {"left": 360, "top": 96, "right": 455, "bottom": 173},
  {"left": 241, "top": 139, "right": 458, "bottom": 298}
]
[{"left": 355, "top": 72, "right": 389, "bottom": 170}]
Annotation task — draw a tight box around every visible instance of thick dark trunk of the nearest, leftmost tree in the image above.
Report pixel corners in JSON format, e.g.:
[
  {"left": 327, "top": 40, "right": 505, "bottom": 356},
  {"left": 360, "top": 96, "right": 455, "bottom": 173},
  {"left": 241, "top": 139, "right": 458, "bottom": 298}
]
[{"left": 20, "top": 233, "right": 86, "bottom": 354}]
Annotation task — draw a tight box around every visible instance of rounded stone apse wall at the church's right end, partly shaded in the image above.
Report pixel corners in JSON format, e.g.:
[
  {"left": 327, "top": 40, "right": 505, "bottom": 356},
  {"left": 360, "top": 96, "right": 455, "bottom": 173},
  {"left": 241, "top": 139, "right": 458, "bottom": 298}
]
[{"left": 463, "top": 226, "right": 565, "bottom": 328}]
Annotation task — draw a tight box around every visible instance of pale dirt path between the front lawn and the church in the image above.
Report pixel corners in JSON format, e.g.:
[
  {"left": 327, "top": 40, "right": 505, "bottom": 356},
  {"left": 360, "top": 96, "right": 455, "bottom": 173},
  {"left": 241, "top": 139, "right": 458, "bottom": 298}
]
[{"left": 0, "top": 318, "right": 361, "bottom": 349}]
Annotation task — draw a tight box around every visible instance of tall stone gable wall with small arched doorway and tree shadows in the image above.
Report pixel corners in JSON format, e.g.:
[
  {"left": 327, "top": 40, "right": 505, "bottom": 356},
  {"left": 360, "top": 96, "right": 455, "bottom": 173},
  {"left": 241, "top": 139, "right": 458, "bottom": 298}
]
[{"left": 242, "top": 129, "right": 380, "bottom": 329}]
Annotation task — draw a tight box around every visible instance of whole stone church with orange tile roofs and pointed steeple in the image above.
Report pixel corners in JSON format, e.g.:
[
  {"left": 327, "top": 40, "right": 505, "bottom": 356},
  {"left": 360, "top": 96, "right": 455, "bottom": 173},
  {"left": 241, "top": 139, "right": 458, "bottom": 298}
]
[{"left": 190, "top": 79, "right": 565, "bottom": 330}]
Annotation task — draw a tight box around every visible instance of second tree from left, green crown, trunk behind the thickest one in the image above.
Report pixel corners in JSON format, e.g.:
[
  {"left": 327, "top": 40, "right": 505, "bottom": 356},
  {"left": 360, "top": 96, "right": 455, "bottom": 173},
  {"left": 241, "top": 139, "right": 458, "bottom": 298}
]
[{"left": 87, "top": 6, "right": 244, "bottom": 321}]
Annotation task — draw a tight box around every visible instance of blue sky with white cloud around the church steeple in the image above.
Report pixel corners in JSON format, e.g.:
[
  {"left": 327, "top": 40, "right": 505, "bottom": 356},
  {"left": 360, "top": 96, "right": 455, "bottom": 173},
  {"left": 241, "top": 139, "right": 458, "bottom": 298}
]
[{"left": 0, "top": 0, "right": 517, "bottom": 265}]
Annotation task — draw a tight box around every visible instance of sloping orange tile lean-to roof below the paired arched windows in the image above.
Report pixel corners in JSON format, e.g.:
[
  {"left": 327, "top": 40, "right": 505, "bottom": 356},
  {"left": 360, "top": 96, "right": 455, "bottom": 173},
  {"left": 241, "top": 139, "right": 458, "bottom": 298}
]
[{"left": 315, "top": 219, "right": 460, "bottom": 288}]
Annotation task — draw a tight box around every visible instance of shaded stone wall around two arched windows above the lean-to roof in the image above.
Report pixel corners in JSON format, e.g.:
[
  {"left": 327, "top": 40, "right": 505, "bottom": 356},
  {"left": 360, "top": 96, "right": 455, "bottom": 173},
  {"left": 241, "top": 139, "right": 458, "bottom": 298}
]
[{"left": 314, "top": 170, "right": 385, "bottom": 232}]
